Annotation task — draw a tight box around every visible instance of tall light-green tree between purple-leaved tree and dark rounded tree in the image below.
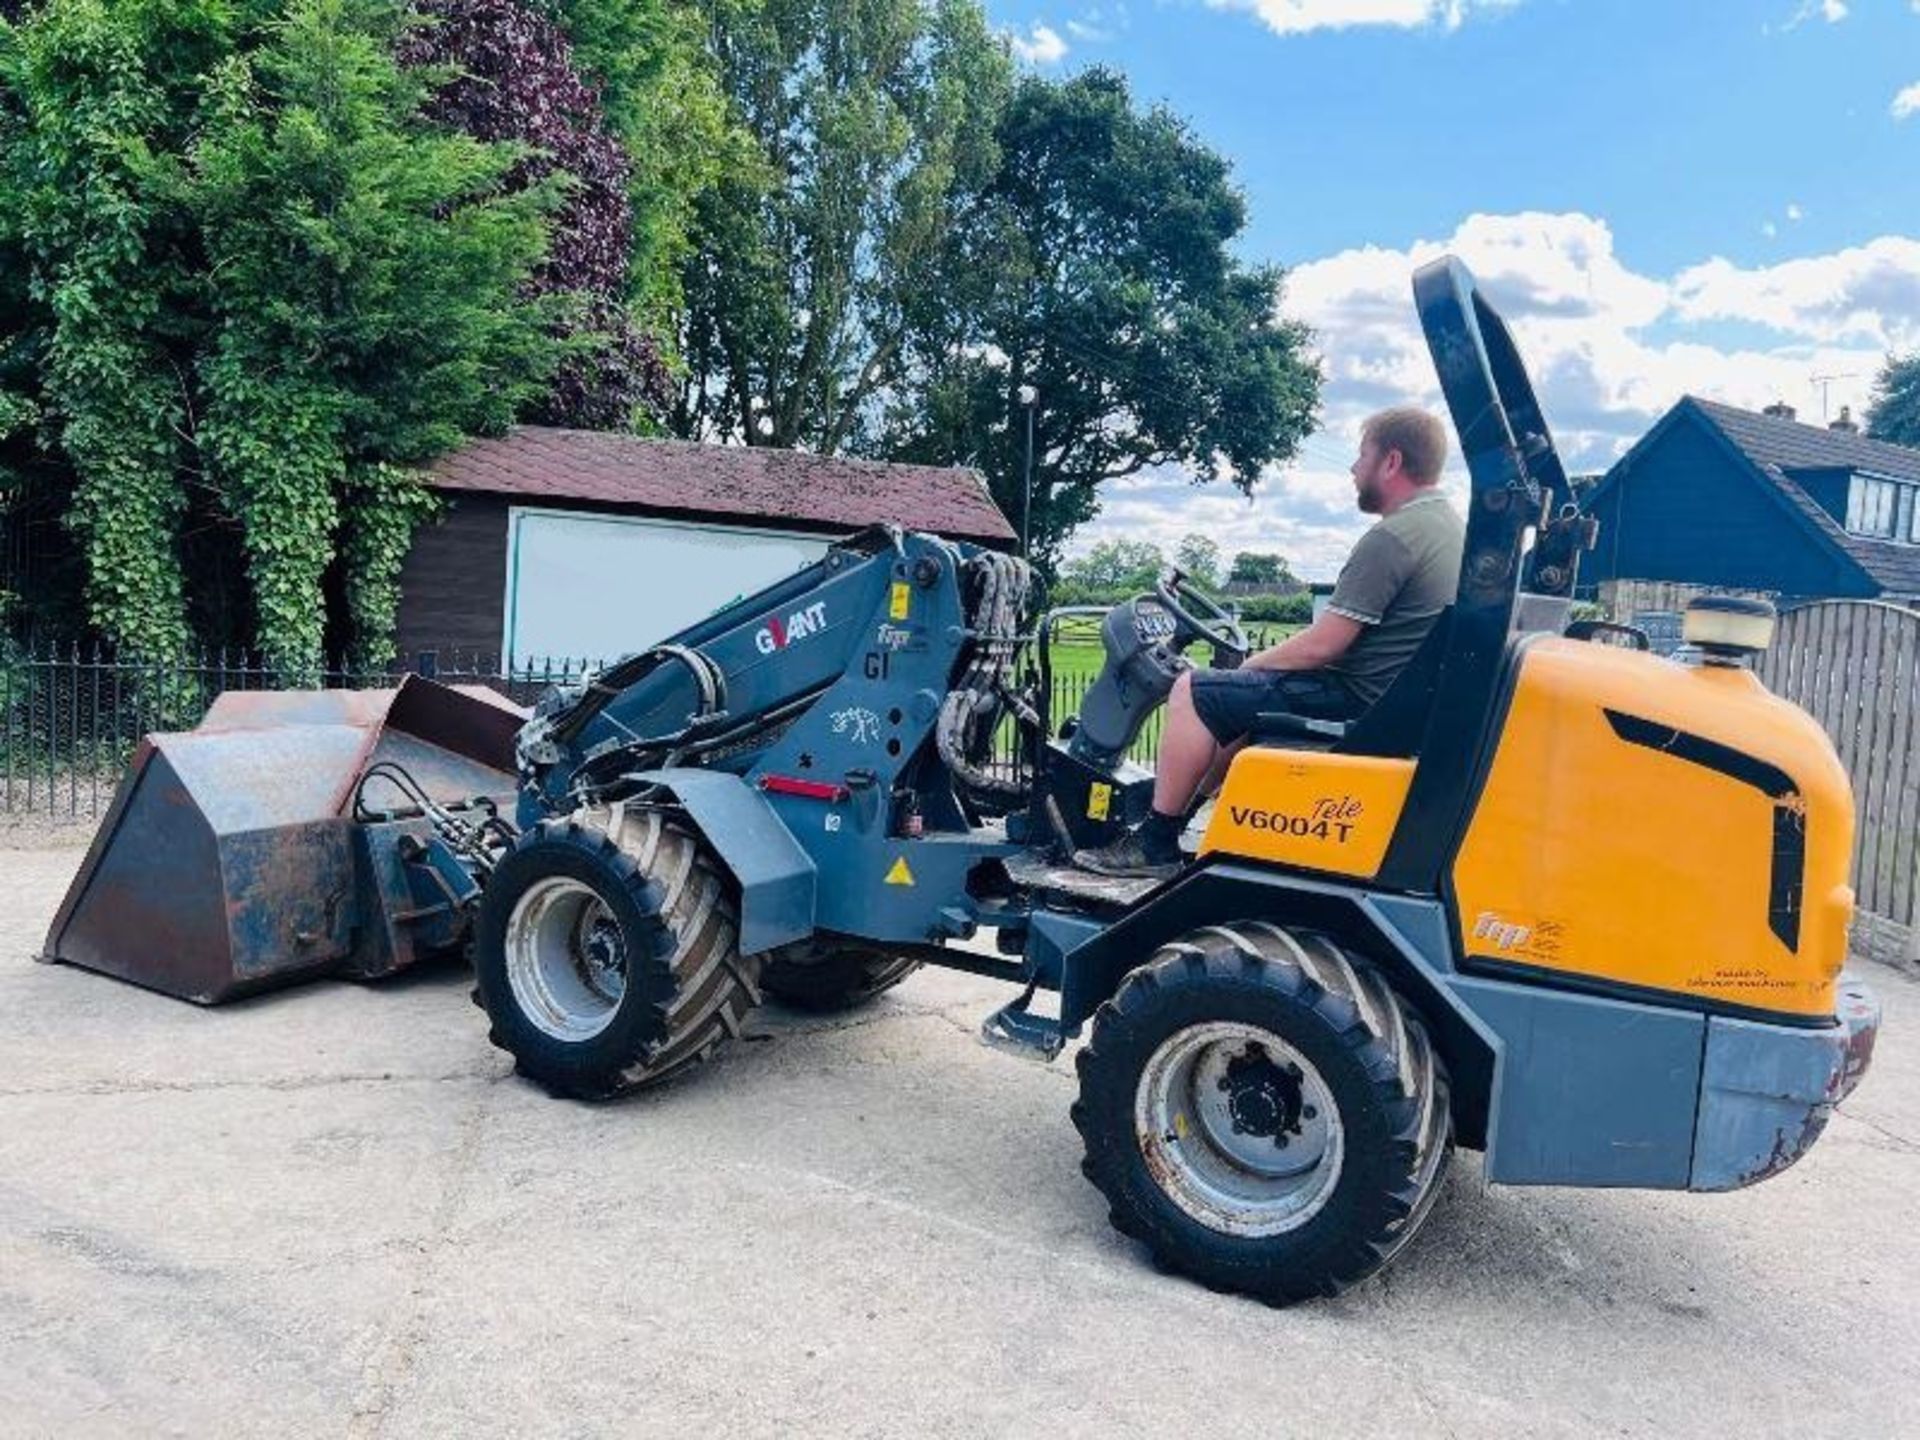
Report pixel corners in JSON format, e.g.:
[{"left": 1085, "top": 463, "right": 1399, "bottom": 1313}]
[{"left": 672, "top": 0, "right": 1012, "bottom": 453}]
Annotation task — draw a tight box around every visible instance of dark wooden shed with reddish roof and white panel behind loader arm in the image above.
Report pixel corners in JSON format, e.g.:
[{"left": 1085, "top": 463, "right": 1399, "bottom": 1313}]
[{"left": 396, "top": 426, "right": 1016, "bottom": 664}]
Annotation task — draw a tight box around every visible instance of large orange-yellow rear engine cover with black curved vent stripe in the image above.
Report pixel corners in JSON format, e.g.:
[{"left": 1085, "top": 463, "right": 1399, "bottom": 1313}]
[{"left": 1452, "top": 639, "right": 1853, "bottom": 1016}]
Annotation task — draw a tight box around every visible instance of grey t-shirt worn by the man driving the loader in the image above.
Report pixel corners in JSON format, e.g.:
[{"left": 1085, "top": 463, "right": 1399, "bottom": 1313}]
[{"left": 1327, "top": 493, "right": 1467, "bottom": 705}]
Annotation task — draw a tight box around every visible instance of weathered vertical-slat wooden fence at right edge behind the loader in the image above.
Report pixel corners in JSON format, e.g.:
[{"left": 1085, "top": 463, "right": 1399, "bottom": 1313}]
[{"left": 1759, "top": 601, "right": 1920, "bottom": 958}]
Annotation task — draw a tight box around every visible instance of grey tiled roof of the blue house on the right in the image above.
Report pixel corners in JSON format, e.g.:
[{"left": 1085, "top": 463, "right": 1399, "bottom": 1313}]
[{"left": 1586, "top": 396, "right": 1920, "bottom": 595}]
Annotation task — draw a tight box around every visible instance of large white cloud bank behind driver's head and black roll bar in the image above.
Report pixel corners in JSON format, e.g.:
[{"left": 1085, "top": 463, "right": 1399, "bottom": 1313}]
[{"left": 1075, "top": 213, "right": 1920, "bottom": 578}]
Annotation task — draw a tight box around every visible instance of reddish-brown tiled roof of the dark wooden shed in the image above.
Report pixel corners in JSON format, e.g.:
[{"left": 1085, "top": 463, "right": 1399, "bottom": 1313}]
[{"left": 426, "top": 424, "right": 1016, "bottom": 541}]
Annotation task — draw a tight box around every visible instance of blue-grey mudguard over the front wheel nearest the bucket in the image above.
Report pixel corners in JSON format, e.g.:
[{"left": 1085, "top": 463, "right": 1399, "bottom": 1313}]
[{"left": 636, "top": 768, "right": 820, "bottom": 954}]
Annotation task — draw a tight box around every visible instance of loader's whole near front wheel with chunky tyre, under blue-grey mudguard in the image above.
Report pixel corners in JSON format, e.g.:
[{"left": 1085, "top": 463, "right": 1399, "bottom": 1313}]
[{"left": 474, "top": 806, "right": 760, "bottom": 1100}]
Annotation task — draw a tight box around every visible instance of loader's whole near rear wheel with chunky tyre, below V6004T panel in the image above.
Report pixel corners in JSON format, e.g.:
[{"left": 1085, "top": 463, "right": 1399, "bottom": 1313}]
[{"left": 1073, "top": 922, "right": 1453, "bottom": 1306}]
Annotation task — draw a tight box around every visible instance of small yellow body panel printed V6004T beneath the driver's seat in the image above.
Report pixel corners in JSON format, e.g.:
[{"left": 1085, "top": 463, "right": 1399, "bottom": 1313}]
[{"left": 1200, "top": 749, "right": 1413, "bottom": 879}]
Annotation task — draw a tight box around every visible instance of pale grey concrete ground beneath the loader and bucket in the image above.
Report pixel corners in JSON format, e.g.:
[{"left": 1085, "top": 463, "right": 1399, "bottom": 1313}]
[{"left": 0, "top": 849, "right": 1920, "bottom": 1436}]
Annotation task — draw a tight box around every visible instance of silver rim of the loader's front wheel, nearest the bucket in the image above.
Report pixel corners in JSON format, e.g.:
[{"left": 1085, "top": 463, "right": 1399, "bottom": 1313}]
[{"left": 505, "top": 876, "right": 626, "bottom": 1041}]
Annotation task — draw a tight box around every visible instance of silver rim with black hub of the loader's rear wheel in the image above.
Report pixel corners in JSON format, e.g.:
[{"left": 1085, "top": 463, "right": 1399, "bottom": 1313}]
[{"left": 1133, "top": 1021, "right": 1346, "bottom": 1236}]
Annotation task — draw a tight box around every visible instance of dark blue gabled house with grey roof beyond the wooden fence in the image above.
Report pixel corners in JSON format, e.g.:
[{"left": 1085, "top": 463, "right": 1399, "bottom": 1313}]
[{"left": 1580, "top": 396, "right": 1920, "bottom": 614}]
